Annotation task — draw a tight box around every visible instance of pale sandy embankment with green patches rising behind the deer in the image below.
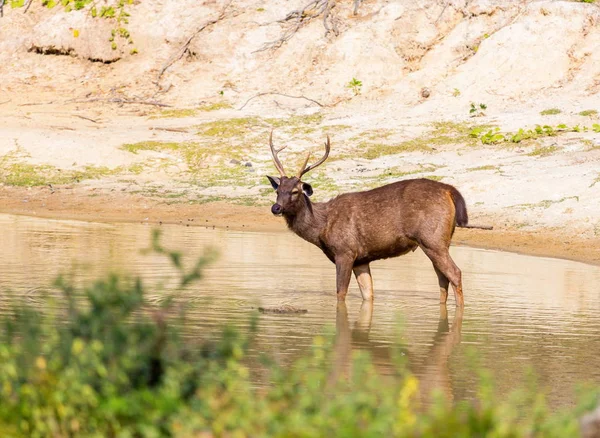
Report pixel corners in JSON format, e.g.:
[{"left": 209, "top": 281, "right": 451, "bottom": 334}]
[{"left": 0, "top": 0, "right": 600, "bottom": 263}]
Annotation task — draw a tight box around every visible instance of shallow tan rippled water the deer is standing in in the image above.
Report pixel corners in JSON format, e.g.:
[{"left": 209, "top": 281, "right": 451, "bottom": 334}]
[{"left": 0, "top": 215, "right": 600, "bottom": 406}]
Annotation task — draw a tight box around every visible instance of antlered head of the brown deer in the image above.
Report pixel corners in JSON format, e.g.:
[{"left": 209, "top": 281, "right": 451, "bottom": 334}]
[{"left": 267, "top": 131, "right": 331, "bottom": 215}]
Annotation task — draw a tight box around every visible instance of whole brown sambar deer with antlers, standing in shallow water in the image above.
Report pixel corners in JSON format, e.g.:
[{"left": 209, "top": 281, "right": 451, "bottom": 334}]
[{"left": 267, "top": 131, "right": 468, "bottom": 307}]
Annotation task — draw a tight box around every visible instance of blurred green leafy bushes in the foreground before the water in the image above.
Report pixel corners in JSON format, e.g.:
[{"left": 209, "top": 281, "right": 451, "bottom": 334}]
[{"left": 0, "top": 234, "right": 598, "bottom": 438}]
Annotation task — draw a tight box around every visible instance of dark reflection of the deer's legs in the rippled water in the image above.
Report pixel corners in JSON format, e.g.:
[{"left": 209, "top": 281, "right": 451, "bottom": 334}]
[{"left": 330, "top": 301, "right": 463, "bottom": 402}]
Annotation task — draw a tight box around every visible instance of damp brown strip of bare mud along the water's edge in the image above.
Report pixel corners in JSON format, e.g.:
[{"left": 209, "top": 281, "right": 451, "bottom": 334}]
[{"left": 0, "top": 187, "right": 600, "bottom": 265}]
